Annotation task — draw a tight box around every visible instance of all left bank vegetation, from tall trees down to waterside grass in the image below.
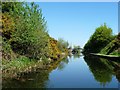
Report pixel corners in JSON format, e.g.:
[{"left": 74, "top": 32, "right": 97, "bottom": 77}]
[{"left": 0, "top": 2, "right": 68, "bottom": 77}]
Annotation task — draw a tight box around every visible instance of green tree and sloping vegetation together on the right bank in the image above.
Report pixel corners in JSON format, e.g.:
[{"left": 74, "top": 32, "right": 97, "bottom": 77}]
[{"left": 83, "top": 24, "right": 120, "bottom": 57}]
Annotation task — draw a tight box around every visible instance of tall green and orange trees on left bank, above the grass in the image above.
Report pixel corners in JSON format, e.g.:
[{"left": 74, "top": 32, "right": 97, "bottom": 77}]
[{"left": 1, "top": 2, "right": 69, "bottom": 60}]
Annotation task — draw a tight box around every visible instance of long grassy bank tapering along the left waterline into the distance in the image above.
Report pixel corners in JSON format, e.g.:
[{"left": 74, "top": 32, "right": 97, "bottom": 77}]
[{"left": 2, "top": 54, "right": 67, "bottom": 79}]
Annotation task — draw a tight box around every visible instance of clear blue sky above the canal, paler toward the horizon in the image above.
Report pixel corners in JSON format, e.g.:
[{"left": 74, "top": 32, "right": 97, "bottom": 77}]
[{"left": 37, "top": 2, "right": 118, "bottom": 47}]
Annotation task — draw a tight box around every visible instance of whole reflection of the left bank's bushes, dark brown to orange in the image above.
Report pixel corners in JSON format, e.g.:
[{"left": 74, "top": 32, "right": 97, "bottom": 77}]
[{"left": 2, "top": 57, "right": 69, "bottom": 88}]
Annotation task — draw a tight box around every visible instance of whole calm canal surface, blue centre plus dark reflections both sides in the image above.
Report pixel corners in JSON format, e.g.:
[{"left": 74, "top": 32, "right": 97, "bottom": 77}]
[{"left": 3, "top": 55, "right": 120, "bottom": 88}]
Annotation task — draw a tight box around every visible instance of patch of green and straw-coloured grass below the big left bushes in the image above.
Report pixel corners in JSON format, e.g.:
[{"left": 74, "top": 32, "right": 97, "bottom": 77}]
[{"left": 2, "top": 56, "right": 43, "bottom": 78}]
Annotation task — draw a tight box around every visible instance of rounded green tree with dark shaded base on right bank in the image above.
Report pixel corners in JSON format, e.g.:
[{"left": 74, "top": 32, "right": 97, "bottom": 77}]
[{"left": 83, "top": 24, "right": 114, "bottom": 53}]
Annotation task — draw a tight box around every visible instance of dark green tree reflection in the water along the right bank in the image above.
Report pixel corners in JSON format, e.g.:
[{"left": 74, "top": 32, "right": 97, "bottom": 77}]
[{"left": 84, "top": 55, "right": 120, "bottom": 87}]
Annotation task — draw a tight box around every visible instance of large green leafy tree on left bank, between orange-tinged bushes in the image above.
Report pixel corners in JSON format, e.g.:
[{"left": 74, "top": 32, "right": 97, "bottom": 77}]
[{"left": 3, "top": 2, "right": 48, "bottom": 59}]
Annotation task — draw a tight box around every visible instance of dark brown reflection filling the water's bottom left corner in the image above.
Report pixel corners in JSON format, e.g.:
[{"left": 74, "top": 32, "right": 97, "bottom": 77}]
[{"left": 2, "top": 70, "right": 49, "bottom": 88}]
